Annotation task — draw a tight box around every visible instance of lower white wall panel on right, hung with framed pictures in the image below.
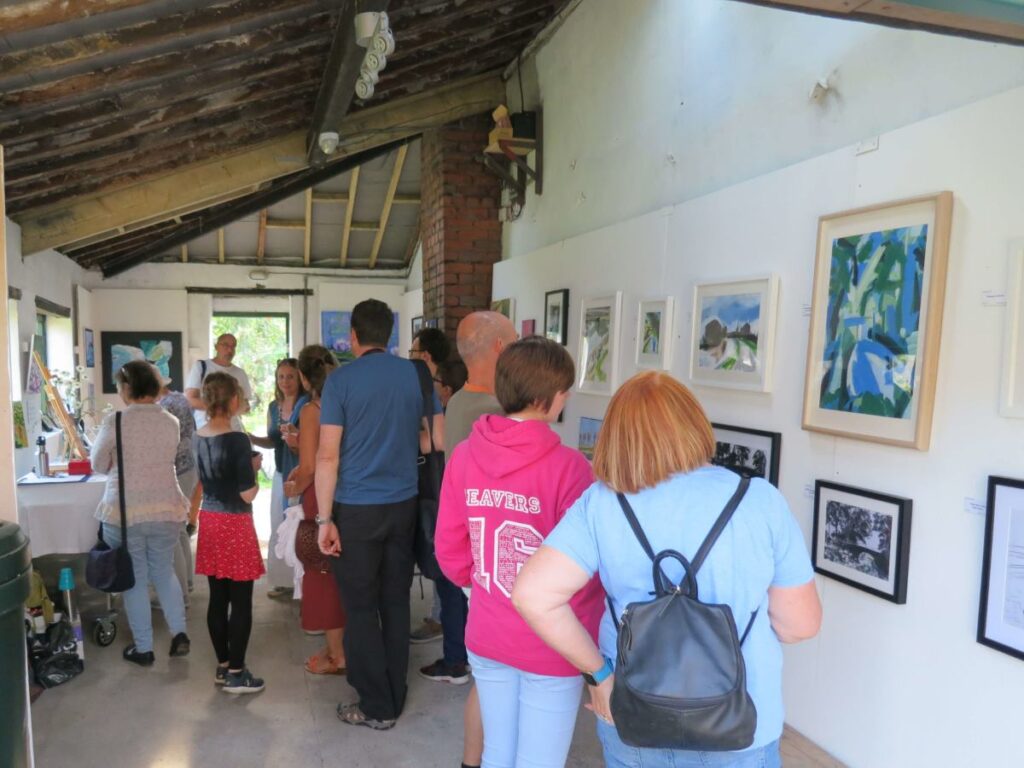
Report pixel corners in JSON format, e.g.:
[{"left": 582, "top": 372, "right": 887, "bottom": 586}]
[{"left": 494, "top": 83, "right": 1024, "bottom": 768}]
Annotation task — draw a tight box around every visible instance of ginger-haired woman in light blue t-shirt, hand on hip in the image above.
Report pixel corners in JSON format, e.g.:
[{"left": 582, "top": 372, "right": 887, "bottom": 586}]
[{"left": 512, "top": 371, "right": 821, "bottom": 768}]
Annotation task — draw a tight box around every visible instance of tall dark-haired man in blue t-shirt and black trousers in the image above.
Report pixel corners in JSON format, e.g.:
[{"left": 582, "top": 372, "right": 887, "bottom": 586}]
[{"left": 315, "top": 299, "right": 423, "bottom": 730}]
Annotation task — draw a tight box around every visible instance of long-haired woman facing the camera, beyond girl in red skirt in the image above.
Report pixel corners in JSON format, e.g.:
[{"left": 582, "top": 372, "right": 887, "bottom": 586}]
[{"left": 249, "top": 357, "right": 307, "bottom": 597}]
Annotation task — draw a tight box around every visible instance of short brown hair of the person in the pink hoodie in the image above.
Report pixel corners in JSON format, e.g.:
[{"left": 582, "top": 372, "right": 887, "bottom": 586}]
[{"left": 495, "top": 336, "right": 575, "bottom": 414}]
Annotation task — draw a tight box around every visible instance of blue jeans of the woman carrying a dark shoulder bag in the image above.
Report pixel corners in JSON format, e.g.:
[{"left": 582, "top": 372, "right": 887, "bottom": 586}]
[{"left": 103, "top": 522, "right": 185, "bottom": 653}]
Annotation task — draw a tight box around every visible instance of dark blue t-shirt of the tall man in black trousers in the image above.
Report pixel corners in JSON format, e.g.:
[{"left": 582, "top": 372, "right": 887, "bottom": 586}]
[{"left": 321, "top": 352, "right": 423, "bottom": 504}]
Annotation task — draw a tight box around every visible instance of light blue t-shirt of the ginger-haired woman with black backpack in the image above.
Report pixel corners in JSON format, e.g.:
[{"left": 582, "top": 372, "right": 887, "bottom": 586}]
[{"left": 544, "top": 467, "right": 814, "bottom": 749}]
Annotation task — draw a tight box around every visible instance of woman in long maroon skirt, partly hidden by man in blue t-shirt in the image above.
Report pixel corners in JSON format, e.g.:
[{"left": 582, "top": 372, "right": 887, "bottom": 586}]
[{"left": 285, "top": 344, "right": 345, "bottom": 675}]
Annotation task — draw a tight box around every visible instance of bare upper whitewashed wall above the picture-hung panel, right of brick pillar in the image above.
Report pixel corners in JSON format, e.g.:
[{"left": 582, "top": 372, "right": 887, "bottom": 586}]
[{"left": 505, "top": 0, "right": 1024, "bottom": 256}]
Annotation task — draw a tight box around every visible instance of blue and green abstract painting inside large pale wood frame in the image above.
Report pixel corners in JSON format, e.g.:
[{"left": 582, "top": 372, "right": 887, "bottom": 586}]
[{"left": 818, "top": 224, "right": 928, "bottom": 419}]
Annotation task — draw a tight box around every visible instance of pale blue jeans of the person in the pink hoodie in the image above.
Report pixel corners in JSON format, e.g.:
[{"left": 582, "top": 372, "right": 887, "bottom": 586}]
[{"left": 469, "top": 651, "right": 583, "bottom": 768}]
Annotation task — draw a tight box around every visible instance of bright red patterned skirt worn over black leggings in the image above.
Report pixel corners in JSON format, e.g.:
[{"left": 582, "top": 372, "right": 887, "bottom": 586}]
[{"left": 196, "top": 509, "right": 266, "bottom": 582}]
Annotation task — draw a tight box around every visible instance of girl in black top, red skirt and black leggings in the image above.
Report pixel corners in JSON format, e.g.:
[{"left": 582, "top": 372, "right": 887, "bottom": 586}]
[{"left": 193, "top": 372, "right": 265, "bottom": 693}]
